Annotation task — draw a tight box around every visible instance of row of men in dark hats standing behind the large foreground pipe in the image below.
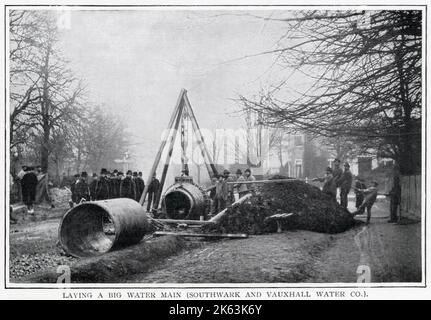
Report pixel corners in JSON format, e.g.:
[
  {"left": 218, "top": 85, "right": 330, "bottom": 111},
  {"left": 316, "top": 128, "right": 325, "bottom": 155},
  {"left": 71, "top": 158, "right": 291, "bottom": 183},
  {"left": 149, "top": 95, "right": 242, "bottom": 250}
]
[{"left": 70, "top": 168, "right": 160, "bottom": 212}]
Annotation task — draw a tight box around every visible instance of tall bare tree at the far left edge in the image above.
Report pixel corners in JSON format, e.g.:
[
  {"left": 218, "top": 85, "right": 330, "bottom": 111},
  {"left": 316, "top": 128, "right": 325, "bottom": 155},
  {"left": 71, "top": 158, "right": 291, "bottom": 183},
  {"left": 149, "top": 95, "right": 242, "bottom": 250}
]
[{"left": 10, "top": 11, "right": 84, "bottom": 171}]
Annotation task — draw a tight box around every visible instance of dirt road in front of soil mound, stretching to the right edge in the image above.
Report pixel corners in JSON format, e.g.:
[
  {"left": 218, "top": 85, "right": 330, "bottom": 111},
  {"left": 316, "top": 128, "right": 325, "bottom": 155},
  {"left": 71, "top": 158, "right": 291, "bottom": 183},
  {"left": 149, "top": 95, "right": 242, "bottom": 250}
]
[{"left": 129, "top": 202, "right": 421, "bottom": 283}]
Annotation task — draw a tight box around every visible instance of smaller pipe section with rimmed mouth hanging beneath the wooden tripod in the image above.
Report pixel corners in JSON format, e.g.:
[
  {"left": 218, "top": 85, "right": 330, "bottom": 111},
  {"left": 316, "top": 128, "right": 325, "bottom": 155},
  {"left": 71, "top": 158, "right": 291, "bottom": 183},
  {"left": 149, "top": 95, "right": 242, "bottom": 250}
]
[{"left": 162, "top": 183, "right": 209, "bottom": 220}]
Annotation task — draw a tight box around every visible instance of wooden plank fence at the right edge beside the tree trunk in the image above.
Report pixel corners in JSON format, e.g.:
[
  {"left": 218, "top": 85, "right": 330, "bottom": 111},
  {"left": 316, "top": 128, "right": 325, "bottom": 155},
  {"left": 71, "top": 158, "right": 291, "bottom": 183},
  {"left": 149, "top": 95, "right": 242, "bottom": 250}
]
[{"left": 400, "top": 175, "right": 421, "bottom": 219}]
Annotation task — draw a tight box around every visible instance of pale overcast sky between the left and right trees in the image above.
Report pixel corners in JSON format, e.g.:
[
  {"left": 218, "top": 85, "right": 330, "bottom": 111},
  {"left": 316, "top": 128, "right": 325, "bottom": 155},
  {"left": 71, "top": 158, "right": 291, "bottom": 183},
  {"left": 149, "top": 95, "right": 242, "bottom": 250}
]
[{"left": 57, "top": 10, "right": 294, "bottom": 175}]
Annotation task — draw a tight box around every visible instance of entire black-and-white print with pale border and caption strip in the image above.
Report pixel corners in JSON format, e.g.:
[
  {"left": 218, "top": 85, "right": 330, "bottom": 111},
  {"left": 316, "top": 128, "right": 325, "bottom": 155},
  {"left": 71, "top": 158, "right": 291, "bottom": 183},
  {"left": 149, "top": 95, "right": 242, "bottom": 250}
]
[{"left": 1, "top": 1, "right": 431, "bottom": 300}]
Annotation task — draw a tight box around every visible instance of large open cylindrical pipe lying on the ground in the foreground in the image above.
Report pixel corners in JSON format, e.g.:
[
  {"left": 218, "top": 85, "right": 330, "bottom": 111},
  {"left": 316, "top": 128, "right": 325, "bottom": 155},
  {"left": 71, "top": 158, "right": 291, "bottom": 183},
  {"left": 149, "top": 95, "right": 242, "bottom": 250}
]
[{"left": 59, "top": 198, "right": 150, "bottom": 257}]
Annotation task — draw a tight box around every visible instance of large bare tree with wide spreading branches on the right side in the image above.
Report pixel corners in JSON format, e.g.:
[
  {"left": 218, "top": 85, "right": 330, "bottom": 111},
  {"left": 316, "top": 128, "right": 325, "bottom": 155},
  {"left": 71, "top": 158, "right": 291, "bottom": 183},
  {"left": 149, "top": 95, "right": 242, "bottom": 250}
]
[{"left": 240, "top": 10, "right": 422, "bottom": 173}]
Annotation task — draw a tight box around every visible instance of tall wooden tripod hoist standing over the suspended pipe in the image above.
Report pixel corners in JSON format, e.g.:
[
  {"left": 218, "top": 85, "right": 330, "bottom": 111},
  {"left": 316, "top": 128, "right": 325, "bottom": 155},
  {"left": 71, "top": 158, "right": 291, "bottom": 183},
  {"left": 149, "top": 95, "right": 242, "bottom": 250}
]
[{"left": 139, "top": 89, "right": 217, "bottom": 208}]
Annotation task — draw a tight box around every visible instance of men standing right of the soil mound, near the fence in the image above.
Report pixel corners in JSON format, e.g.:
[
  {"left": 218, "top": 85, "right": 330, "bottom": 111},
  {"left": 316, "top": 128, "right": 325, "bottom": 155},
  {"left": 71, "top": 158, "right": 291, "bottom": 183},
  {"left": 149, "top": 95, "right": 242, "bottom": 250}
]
[{"left": 313, "top": 159, "right": 401, "bottom": 224}]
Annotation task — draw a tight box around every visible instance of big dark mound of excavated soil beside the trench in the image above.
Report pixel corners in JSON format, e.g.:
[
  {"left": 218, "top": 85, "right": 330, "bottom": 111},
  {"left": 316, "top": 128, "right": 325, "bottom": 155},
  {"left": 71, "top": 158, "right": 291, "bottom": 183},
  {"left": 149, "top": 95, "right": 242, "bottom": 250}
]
[{"left": 205, "top": 176, "right": 354, "bottom": 234}]
